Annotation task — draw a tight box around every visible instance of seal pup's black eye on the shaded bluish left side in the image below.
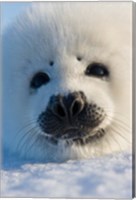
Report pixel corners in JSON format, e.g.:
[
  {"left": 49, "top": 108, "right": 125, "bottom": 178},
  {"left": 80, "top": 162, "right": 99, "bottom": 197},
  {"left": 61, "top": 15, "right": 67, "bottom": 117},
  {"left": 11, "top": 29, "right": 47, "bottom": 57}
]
[{"left": 30, "top": 72, "right": 50, "bottom": 89}]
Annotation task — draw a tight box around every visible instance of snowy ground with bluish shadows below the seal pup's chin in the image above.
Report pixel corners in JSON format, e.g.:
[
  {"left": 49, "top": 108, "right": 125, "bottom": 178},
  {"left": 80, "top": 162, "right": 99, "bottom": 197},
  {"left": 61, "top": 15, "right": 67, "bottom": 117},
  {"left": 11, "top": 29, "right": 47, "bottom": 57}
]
[{"left": 1, "top": 153, "right": 132, "bottom": 199}]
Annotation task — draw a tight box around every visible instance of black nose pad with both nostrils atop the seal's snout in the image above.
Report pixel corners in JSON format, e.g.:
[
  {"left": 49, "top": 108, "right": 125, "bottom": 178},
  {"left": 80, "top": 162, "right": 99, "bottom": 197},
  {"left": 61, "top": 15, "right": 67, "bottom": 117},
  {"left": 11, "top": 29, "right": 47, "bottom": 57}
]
[{"left": 50, "top": 92, "right": 85, "bottom": 120}]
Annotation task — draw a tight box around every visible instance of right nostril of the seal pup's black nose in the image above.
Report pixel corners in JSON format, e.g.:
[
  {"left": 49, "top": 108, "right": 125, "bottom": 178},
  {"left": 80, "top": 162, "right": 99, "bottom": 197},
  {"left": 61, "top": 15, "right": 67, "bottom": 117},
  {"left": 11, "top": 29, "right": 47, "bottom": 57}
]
[{"left": 71, "top": 100, "right": 83, "bottom": 116}]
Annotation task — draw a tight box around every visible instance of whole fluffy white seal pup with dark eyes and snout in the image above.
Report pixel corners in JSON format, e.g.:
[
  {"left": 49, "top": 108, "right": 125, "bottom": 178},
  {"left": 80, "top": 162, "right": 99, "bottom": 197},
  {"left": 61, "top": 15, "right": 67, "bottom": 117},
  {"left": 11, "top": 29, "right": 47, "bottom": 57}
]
[{"left": 2, "top": 2, "right": 132, "bottom": 162}]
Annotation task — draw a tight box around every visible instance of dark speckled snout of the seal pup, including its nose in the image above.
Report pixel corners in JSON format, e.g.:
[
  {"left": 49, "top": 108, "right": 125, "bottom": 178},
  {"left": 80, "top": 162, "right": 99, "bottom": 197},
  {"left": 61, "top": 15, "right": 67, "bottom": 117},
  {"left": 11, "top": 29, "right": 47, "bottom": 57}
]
[{"left": 38, "top": 91, "right": 105, "bottom": 142}]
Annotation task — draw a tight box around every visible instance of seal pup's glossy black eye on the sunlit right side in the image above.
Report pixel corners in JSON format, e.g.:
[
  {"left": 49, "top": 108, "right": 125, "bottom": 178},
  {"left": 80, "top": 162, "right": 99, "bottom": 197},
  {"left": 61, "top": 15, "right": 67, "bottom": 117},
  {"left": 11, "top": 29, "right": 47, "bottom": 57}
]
[{"left": 85, "top": 62, "right": 109, "bottom": 78}]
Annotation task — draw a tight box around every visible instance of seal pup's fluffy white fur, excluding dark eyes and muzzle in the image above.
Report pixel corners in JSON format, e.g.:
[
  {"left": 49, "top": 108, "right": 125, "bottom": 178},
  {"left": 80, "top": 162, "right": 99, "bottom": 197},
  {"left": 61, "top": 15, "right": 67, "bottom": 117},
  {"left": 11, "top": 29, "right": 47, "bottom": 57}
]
[{"left": 3, "top": 2, "right": 132, "bottom": 161}]
